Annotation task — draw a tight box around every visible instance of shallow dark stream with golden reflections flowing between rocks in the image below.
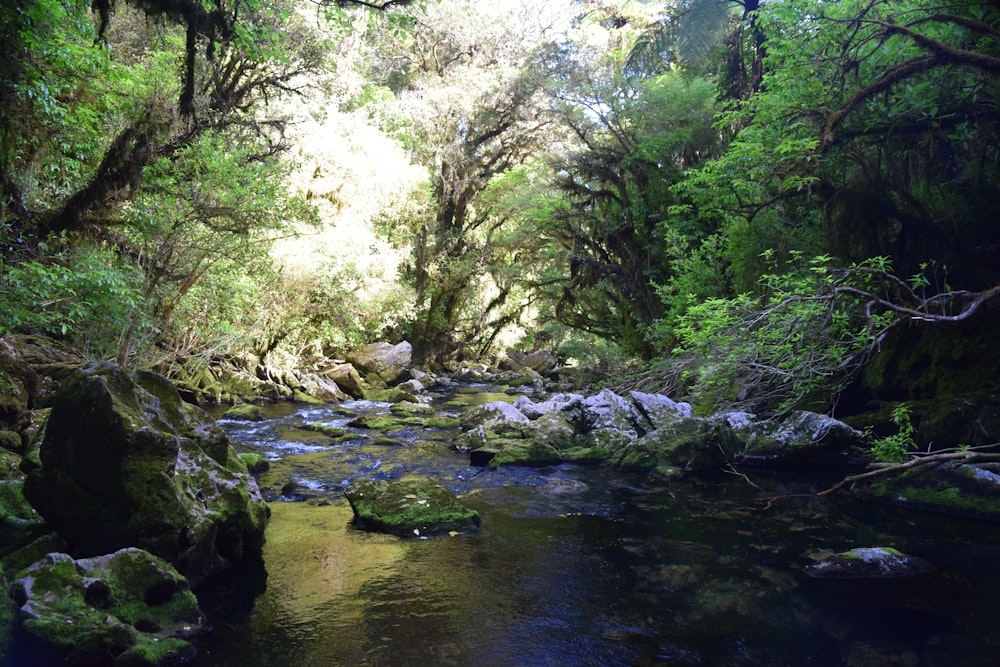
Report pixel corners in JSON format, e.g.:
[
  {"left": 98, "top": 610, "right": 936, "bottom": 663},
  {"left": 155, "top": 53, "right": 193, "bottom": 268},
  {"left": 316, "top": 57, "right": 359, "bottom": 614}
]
[{"left": 191, "top": 386, "right": 1000, "bottom": 667}]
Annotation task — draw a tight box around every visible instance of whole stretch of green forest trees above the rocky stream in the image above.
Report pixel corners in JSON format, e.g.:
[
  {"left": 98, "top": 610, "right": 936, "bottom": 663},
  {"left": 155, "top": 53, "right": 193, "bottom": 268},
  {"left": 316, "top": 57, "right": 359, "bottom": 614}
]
[{"left": 0, "top": 0, "right": 1000, "bottom": 412}]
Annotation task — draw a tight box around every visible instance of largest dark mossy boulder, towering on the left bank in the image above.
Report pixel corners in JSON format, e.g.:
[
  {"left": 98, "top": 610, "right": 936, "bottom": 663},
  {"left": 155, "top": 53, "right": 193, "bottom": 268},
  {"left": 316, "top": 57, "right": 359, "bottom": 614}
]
[{"left": 24, "top": 363, "right": 267, "bottom": 583}]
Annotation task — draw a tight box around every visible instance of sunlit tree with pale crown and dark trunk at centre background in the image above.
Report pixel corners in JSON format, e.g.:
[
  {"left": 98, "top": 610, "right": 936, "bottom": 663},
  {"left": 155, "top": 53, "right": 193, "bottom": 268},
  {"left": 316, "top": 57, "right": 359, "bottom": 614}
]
[{"left": 360, "top": 2, "right": 568, "bottom": 365}]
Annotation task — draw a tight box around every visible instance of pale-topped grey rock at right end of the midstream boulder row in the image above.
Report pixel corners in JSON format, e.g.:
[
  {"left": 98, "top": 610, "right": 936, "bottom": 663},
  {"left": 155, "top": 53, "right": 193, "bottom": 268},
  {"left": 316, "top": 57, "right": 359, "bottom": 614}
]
[{"left": 723, "top": 411, "right": 862, "bottom": 466}]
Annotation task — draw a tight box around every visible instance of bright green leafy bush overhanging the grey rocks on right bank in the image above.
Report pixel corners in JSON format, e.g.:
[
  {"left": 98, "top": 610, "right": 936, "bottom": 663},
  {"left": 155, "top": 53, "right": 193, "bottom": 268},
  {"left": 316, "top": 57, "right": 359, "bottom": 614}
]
[{"left": 672, "top": 253, "right": 893, "bottom": 413}]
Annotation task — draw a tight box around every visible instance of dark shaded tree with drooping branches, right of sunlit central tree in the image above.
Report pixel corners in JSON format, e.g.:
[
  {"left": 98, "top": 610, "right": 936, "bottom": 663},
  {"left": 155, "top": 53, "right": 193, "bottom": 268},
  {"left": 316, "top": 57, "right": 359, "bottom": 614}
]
[{"left": 556, "top": 19, "right": 719, "bottom": 355}]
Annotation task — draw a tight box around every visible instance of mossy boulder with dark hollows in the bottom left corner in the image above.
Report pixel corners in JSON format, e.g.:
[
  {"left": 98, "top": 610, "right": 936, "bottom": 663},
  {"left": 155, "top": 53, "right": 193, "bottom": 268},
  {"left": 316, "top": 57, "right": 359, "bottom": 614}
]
[{"left": 11, "top": 549, "right": 206, "bottom": 667}]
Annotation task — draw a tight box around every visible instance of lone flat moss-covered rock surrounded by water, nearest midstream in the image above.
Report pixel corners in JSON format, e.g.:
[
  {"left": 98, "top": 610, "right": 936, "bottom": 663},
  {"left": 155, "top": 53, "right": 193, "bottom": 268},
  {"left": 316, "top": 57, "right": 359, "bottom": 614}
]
[{"left": 346, "top": 480, "right": 480, "bottom": 537}]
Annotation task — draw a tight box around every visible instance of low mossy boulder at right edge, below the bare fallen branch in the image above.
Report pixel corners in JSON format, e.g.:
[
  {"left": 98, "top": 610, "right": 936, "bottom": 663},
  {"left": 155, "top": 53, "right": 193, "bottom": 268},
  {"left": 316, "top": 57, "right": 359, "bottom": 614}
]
[{"left": 860, "top": 461, "right": 1000, "bottom": 521}]
